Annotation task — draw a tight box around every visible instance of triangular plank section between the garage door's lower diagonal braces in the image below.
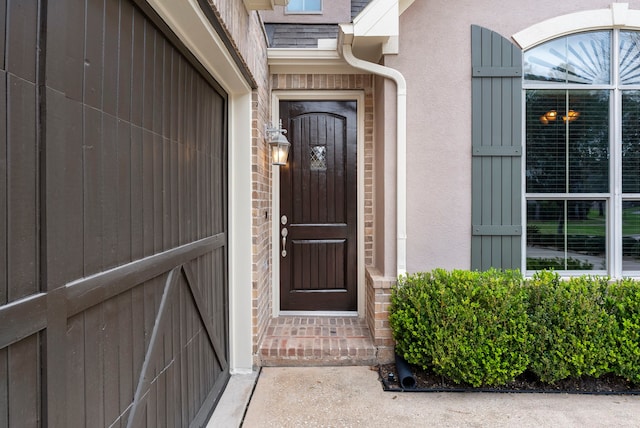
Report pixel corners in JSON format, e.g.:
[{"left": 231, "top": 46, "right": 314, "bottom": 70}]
[{"left": 119, "top": 268, "right": 226, "bottom": 427}]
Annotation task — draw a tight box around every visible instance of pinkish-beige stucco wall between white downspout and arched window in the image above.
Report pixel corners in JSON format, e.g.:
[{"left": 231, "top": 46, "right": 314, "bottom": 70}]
[{"left": 385, "top": 0, "right": 616, "bottom": 272}]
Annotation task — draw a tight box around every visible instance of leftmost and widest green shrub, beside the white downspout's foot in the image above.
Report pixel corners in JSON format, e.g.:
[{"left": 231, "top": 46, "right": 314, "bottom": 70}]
[{"left": 389, "top": 269, "right": 530, "bottom": 386}]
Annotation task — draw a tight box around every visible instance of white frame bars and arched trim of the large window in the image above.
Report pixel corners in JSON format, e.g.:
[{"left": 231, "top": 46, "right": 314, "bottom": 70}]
[{"left": 524, "top": 20, "right": 640, "bottom": 279}]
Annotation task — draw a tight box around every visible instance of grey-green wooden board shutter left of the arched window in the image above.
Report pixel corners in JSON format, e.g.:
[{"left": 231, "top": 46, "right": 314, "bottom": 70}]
[{"left": 471, "top": 25, "right": 522, "bottom": 270}]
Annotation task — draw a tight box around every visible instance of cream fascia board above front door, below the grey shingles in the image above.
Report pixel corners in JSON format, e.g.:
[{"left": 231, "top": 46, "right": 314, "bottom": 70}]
[{"left": 267, "top": 48, "right": 359, "bottom": 74}]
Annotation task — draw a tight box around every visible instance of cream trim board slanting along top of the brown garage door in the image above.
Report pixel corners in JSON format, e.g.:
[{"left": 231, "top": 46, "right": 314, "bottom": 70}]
[{"left": 147, "top": 0, "right": 251, "bottom": 94}]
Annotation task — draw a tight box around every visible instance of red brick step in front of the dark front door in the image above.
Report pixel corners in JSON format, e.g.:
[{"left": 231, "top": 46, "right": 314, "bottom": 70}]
[{"left": 259, "top": 316, "right": 377, "bottom": 367}]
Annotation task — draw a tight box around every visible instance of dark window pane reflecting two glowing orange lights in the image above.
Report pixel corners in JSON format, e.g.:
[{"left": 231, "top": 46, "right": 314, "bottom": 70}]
[{"left": 526, "top": 90, "right": 609, "bottom": 193}]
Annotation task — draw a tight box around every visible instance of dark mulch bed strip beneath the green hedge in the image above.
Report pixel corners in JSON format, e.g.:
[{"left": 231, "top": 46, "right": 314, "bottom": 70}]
[{"left": 378, "top": 363, "right": 640, "bottom": 395}]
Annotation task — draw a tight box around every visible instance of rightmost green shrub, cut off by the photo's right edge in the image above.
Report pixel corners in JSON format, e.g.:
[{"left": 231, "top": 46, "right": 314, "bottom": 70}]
[{"left": 607, "top": 279, "right": 640, "bottom": 384}]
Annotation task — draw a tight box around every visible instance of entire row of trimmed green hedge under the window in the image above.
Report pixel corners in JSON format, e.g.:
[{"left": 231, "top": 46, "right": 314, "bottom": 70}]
[{"left": 389, "top": 269, "right": 640, "bottom": 386}]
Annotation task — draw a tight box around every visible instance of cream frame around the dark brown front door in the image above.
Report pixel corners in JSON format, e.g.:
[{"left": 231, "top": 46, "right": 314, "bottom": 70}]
[{"left": 271, "top": 90, "right": 365, "bottom": 318}]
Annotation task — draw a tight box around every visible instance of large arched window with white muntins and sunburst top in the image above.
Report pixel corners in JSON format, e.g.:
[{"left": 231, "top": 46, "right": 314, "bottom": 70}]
[{"left": 524, "top": 30, "right": 640, "bottom": 277}]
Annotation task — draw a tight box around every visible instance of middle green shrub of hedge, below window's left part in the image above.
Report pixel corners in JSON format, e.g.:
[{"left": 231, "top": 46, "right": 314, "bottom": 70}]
[{"left": 527, "top": 271, "right": 616, "bottom": 383}]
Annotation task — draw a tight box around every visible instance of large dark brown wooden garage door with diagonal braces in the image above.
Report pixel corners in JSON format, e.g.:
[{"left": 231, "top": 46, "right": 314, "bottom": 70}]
[{"left": 0, "top": 0, "right": 229, "bottom": 426}]
